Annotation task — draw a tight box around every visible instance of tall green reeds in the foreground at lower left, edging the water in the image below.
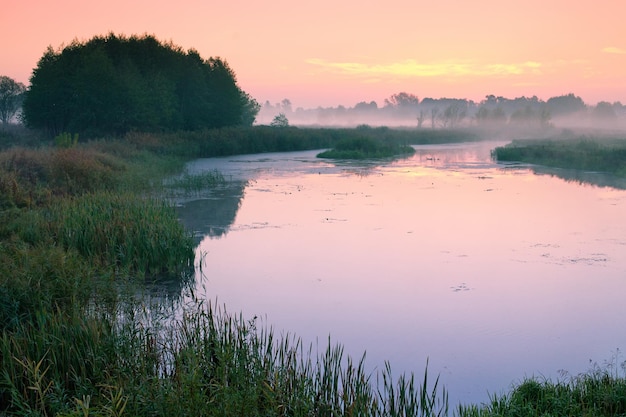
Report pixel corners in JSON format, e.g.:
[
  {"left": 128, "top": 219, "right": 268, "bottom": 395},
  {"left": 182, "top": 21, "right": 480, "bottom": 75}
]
[{"left": 0, "top": 296, "right": 447, "bottom": 416}]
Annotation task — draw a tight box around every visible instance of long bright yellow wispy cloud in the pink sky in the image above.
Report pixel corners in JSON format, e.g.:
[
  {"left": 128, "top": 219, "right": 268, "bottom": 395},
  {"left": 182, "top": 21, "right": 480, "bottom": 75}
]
[{"left": 306, "top": 58, "right": 542, "bottom": 78}]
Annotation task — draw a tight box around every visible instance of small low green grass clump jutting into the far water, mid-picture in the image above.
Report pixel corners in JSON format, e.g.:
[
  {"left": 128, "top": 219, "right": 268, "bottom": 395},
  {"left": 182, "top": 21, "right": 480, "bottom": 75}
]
[{"left": 317, "top": 137, "right": 415, "bottom": 159}]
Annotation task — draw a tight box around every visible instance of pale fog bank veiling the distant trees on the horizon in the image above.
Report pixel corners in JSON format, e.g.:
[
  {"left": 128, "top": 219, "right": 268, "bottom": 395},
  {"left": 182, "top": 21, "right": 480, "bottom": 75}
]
[{"left": 256, "top": 93, "right": 626, "bottom": 131}]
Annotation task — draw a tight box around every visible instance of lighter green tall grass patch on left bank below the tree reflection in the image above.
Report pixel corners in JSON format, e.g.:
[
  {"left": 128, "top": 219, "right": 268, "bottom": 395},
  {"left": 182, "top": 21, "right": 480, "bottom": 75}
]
[{"left": 10, "top": 192, "right": 195, "bottom": 275}]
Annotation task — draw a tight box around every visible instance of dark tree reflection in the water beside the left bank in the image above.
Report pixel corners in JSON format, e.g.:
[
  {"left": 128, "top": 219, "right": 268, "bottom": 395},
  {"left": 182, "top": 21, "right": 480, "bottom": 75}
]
[{"left": 177, "top": 181, "right": 247, "bottom": 244}]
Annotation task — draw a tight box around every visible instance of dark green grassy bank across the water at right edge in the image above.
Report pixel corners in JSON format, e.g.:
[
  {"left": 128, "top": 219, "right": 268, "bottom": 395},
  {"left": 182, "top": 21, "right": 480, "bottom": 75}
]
[{"left": 493, "top": 136, "right": 626, "bottom": 177}]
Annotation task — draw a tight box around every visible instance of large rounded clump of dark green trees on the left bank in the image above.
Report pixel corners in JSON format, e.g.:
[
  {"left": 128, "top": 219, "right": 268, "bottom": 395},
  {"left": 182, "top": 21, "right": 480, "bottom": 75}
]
[{"left": 22, "top": 33, "right": 260, "bottom": 137}]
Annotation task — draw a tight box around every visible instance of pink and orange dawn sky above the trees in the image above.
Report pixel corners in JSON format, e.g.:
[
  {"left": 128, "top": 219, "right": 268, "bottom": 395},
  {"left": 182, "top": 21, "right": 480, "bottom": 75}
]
[{"left": 0, "top": 0, "right": 626, "bottom": 108}]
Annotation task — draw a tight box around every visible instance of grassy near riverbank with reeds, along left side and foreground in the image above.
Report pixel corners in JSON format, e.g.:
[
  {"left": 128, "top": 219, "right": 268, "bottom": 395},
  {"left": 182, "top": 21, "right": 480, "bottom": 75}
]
[{"left": 0, "top": 127, "right": 626, "bottom": 416}]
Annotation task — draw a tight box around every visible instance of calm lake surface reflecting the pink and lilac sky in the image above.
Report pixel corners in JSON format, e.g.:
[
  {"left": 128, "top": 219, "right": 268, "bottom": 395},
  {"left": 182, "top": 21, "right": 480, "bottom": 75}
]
[{"left": 180, "top": 142, "right": 626, "bottom": 405}]
